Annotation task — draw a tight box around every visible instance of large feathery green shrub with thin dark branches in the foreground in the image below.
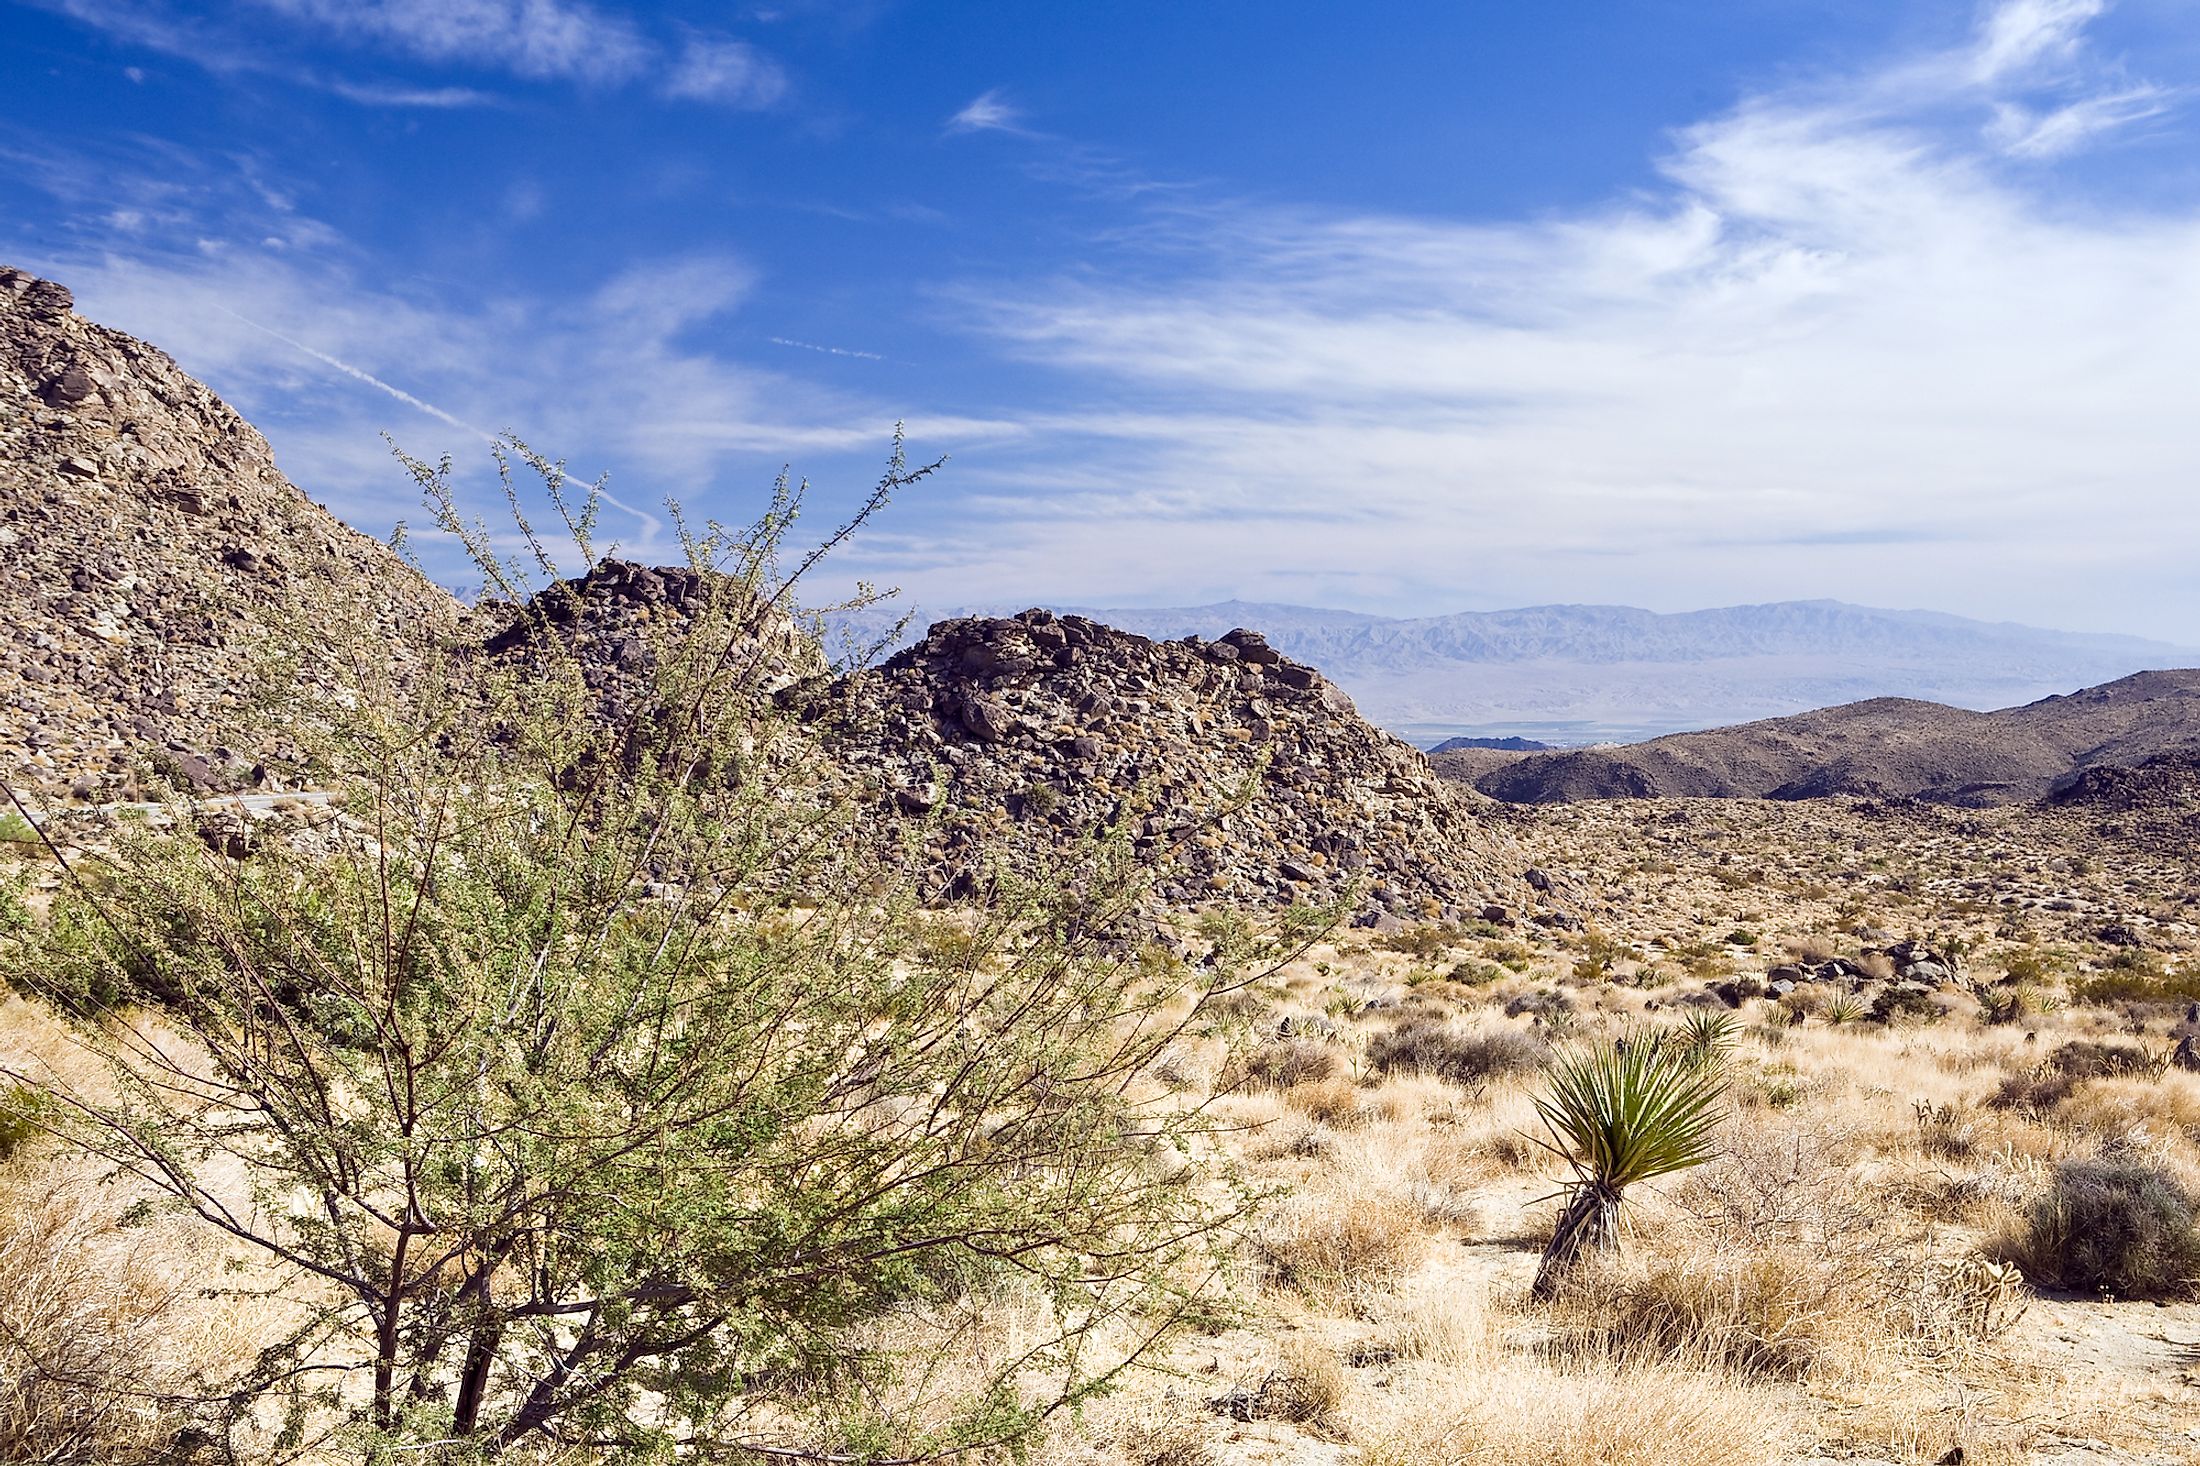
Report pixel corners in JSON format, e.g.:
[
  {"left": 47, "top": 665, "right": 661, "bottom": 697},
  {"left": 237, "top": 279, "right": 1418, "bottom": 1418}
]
[{"left": 8, "top": 435, "right": 1283, "bottom": 1462}]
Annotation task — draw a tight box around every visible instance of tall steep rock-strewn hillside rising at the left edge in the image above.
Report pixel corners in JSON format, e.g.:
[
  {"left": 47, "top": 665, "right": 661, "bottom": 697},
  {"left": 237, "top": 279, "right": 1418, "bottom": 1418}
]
[{"left": 0, "top": 266, "right": 462, "bottom": 801}]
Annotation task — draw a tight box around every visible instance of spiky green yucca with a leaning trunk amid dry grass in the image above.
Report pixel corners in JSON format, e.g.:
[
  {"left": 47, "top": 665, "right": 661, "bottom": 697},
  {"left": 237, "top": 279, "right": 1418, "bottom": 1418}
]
[{"left": 1533, "top": 1039, "right": 1727, "bottom": 1299}]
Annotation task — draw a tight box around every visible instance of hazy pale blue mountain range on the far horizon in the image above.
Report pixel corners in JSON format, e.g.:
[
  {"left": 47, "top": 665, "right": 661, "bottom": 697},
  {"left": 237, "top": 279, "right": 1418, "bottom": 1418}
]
[{"left": 849, "top": 601, "right": 2200, "bottom": 746}]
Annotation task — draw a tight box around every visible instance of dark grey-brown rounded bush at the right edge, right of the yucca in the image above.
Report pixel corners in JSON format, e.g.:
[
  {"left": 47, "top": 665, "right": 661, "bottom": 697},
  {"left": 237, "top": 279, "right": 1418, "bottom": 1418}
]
[{"left": 2000, "top": 1158, "right": 2200, "bottom": 1299}]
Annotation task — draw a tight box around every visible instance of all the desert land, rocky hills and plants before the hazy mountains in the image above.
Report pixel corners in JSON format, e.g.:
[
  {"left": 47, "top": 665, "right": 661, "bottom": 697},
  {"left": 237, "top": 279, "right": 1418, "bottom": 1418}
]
[{"left": 0, "top": 259, "right": 2200, "bottom": 1466}]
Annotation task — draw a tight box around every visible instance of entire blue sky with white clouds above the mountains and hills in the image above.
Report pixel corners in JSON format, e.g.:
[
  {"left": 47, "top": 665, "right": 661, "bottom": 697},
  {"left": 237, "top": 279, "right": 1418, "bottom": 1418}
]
[{"left": 0, "top": 0, "right": 2200, "bottom": 643}]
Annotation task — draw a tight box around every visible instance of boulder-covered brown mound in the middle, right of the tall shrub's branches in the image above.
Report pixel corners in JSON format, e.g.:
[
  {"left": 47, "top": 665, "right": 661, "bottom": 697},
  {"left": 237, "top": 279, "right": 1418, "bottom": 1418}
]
[{"left": 829, "top": 610, "right": 1509, "bottom": 925}]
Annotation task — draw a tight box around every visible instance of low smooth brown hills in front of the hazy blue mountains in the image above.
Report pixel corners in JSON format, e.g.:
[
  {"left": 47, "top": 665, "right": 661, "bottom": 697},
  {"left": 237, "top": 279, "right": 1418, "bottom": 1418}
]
[{"left": 1470, "top": 671, "right": 2200, "bottom": 806}]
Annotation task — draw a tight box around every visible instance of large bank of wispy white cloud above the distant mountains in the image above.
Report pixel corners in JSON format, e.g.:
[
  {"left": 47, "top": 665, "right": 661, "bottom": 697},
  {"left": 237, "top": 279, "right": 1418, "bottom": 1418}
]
[{"left": 884, "top": 0, "right": 2200, "bottom": 634}]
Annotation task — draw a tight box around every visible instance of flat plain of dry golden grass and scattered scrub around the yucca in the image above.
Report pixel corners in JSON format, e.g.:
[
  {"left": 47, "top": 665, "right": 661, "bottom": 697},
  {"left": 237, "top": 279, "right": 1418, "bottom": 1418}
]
[{"left": 0, "top": 801, "right": 2200, "bottom": 1466}]
